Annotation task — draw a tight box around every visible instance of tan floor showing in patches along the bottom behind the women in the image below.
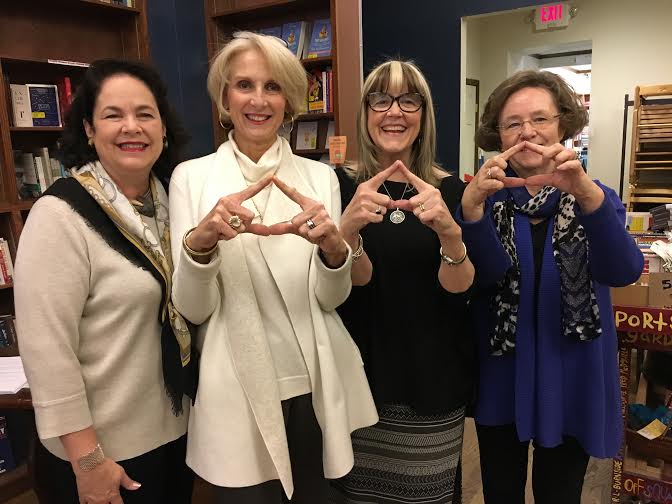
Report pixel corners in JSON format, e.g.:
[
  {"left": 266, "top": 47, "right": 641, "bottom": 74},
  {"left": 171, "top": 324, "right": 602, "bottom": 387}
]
[{"left": 7, "top": 419, "right": 611, "bottom": 504}]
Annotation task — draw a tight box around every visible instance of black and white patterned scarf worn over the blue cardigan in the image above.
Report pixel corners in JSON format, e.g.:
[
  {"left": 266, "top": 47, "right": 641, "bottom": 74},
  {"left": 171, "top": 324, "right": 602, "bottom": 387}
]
[{"left": 490, "top": 186, "right": 602, "bottom": 355}]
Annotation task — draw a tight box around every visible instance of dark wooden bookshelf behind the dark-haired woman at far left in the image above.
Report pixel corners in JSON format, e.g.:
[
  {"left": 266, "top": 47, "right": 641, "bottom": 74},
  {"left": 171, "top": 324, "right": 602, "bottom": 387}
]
[{"left": 0, "top": 0, "right": 149, "bottom": 502}]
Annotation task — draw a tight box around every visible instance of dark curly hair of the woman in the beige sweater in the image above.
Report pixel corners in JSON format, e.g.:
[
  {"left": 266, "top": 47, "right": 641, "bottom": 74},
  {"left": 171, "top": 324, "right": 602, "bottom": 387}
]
[{"left": 57, "top": 59, "right": 189, "bottom": 183}]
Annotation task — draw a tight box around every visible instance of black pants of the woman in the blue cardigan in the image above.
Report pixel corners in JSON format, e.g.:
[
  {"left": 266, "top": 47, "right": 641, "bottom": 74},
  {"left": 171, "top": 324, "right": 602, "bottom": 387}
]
[{"left": 476, "top": 424, "right": 590, "bottom": 504}]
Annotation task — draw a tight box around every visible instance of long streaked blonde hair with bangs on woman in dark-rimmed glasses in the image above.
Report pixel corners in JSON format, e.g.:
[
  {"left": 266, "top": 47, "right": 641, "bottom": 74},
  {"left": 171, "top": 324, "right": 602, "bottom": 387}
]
[{"left": 347, "top": 60, "right": 440, "bottom": 186}]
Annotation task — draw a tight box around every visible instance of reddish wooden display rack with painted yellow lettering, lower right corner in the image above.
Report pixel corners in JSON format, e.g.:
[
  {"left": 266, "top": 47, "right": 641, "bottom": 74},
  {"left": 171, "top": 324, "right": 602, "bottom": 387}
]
[{"left": 611, "top": 306, "right": 672, "bottom": 504}]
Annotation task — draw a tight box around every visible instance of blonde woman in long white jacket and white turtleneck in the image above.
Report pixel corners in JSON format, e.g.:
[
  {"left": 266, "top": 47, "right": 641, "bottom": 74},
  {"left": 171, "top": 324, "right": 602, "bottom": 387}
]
[{"left": 170, "top": 32, "right": 377, "bottom": 504}]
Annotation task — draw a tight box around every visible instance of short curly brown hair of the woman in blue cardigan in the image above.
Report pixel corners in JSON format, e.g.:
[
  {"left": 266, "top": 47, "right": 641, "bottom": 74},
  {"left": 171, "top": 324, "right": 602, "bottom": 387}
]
[{"left": 476, "top": 70, "right": 588, "bottom": 151}]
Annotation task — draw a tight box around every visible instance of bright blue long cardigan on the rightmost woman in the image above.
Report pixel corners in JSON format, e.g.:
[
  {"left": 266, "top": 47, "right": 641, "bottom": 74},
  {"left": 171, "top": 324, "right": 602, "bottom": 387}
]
[{"left": 456, "top": 182, "right": 644, "bottom": 458}]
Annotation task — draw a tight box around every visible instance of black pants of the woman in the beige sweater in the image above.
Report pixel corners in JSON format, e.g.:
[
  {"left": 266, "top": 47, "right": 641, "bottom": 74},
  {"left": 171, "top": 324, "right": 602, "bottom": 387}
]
[{"left": 35, "top": 436, "right": 194, "bottom": 504}]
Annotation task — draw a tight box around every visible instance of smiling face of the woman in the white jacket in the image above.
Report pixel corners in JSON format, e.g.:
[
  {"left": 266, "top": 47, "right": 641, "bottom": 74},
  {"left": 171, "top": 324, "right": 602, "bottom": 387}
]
[{"left": 223, "top": 50, "right": 287, "bottom": 158}]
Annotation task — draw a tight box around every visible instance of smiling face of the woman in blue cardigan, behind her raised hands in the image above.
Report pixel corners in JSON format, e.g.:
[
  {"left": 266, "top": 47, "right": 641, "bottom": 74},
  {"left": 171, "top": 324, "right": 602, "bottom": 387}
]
[{"left": 499, "top": 87, "right": 563, "bottom": 177}]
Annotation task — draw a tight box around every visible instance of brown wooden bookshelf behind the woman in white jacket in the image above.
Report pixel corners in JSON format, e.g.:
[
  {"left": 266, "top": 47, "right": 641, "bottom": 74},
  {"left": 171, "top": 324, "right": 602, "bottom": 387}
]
[{"left": 205, "top": 0, "right": 362, "bottom": 160}]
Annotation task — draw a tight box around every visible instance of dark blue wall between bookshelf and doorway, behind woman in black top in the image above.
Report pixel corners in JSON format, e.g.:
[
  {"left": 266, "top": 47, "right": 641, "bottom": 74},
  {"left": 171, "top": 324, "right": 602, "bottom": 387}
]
[{"left": 362, "top": 0, "right": 549, "bottom": 171}]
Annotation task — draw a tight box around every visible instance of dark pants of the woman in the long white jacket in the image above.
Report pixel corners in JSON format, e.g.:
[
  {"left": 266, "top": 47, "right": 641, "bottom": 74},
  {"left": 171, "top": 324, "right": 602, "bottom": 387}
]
[{"left": 215, "top": 394, "right": 329, "bottom": 504}]
